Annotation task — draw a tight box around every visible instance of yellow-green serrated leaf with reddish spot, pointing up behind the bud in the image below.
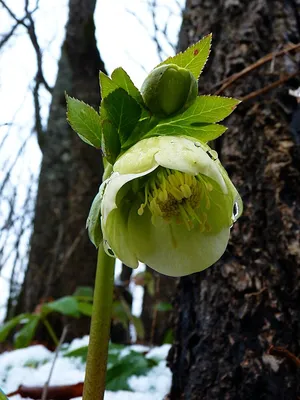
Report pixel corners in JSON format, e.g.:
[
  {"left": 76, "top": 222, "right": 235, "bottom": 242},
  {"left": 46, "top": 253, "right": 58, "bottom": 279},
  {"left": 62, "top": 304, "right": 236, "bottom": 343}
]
[{"left": 158, "top": 34, "right": 212, "bottom": 79}]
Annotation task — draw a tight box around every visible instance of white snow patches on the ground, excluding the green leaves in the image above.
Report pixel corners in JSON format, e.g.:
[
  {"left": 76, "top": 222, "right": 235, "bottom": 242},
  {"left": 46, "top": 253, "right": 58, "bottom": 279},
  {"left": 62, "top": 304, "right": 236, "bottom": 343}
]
[{"left": 0, "top": 336, "right": 171, "bottom": 400}]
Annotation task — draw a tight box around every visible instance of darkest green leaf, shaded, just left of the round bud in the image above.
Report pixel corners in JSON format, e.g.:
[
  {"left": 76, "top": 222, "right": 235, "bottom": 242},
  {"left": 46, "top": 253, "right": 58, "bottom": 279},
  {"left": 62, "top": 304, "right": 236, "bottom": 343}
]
[{"left": 101, "top": 88, "right": 141, "bottom": 145}]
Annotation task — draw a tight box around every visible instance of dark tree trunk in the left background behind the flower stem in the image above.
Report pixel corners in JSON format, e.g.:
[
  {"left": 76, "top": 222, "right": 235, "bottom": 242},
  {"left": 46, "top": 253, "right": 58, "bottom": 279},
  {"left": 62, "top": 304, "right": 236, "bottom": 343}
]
[{"left": 17, "top": 0, "right": 104, "bottom": 336}]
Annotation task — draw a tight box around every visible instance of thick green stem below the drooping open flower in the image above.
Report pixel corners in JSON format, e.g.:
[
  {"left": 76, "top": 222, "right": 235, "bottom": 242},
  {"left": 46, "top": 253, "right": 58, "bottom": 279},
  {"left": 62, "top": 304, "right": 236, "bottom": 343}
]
[{"left": 83, "top": 244, "right": 115, "bottom": 400}]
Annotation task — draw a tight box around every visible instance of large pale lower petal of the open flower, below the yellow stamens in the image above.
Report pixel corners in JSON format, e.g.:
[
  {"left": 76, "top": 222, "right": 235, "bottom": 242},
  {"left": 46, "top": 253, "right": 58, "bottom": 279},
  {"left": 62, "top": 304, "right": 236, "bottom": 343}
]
[{"left": 128, "top": 208, "right": 230, "bottom": 276}]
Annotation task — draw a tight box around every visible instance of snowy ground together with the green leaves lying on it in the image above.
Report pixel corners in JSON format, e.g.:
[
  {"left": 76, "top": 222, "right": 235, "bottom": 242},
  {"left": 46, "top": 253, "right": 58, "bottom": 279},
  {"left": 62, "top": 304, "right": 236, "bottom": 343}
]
[{"left": 0, "top": 336, "right": 171, "bottom": 400}]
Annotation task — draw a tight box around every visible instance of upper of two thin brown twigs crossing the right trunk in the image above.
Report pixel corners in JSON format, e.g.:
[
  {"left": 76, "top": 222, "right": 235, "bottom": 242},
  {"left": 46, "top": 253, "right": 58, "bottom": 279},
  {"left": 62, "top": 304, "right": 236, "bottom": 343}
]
[{"left": 215, "top": 43, "right": 300, "bottom": 95}]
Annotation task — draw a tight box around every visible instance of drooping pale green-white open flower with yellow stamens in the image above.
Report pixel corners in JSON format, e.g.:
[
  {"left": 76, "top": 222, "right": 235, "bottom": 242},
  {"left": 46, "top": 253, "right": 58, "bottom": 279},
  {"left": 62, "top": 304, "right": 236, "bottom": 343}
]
[{"left": 95, "top": 136, "right": 242, "bottom": 276}]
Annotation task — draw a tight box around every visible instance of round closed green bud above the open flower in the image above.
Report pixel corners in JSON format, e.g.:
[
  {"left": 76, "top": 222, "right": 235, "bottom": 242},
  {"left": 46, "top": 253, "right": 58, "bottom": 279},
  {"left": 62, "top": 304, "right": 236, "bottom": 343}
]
[{"left": 141, "top": 64, "right": 198, "bottom": 116}]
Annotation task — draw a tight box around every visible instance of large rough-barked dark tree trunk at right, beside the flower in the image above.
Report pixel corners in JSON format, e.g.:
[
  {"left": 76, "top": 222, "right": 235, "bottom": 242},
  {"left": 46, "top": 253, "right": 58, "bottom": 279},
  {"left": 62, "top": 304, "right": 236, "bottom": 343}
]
[{"left": 169, "top": 0, "right": 300, "bottom": 400}]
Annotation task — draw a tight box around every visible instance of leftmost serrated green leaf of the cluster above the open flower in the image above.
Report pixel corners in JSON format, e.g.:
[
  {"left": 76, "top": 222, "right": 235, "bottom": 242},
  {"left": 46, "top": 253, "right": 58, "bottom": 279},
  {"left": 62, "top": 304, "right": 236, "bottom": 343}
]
[{"left": 66, "top": 95, "right": 101, "bottom": 148}]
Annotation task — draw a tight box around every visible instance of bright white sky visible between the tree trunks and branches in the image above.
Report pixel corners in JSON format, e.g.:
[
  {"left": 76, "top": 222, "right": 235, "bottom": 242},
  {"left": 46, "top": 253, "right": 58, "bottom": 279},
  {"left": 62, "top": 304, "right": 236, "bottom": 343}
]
[{"left": 0, "top": 0, "right": 184, "bottom": 321}]
